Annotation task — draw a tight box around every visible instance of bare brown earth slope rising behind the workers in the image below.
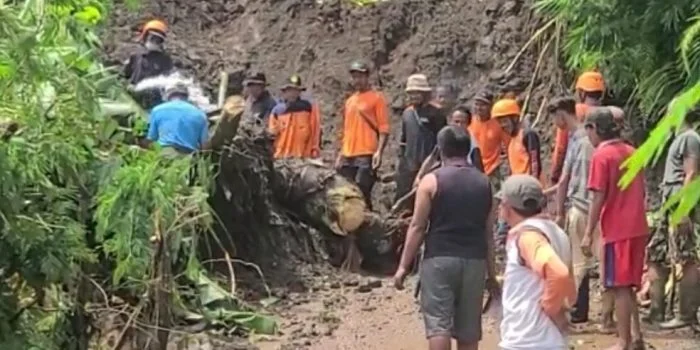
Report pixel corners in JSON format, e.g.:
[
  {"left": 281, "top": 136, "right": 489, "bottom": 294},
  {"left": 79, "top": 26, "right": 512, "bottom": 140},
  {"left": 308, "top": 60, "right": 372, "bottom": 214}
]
[{"left": 103, "top": 0, "right": 549, "bottom": 208}]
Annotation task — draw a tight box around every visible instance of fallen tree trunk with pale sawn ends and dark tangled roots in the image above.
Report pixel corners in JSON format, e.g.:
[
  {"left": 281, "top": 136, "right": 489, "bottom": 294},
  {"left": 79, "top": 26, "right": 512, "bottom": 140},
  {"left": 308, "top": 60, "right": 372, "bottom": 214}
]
[{"left": 209, "top": 96, "right": 408, "bottom": 278}]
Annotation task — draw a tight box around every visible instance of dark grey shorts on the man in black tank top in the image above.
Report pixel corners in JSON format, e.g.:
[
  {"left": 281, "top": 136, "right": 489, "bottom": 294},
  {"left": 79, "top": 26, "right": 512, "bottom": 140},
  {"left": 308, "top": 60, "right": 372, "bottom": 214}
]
[{"left": 420, "top": 257, "right": 486, "bottom": 343}]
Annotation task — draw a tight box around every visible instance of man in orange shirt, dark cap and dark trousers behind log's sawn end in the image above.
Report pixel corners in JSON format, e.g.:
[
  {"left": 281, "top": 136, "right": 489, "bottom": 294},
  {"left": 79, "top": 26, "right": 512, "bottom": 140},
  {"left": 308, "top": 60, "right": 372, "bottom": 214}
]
[{"left": 335, "top": 62, "right": 389, "bottom": 208}]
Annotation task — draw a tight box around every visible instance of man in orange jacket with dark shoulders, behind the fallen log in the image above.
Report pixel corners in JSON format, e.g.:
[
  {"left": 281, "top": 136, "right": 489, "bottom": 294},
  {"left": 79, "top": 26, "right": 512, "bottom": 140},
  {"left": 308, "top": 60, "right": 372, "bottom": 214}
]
[{"left": 268, "top": 75, "right": 321, "bottom": 159}]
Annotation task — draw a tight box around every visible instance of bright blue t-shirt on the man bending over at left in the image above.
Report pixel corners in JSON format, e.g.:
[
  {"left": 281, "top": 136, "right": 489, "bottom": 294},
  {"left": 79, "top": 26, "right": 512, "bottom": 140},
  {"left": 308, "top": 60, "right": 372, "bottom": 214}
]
[{"left": 148, "top": 100, "right": 209, "bottom": 151}]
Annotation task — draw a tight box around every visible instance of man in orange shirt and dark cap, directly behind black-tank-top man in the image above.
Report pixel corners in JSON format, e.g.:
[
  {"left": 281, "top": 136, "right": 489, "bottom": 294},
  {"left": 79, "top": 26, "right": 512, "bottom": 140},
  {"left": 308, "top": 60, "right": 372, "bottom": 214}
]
[{"left": 469, "top": 91, "right": 508, "bottom": 190}]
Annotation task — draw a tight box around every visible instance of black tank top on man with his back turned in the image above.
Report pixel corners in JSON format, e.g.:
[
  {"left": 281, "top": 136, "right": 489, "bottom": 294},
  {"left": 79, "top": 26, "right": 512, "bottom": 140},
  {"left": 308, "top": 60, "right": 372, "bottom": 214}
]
[{"left": 425, "top": 165, "right": 493, "bottom": 259}]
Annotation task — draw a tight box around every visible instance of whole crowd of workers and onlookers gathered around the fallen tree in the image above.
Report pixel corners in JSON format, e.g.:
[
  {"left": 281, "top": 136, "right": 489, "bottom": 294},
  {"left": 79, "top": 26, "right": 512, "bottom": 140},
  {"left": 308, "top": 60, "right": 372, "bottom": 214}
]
[{"left": 125, "top": 21, "right": 700, "bottom": 350}]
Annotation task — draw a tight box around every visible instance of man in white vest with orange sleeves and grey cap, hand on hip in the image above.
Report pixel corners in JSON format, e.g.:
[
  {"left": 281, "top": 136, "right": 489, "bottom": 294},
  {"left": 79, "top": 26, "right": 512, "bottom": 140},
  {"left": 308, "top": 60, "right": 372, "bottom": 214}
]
[{"left": 496, "top": 175, "right": 576, "bottom": 350}]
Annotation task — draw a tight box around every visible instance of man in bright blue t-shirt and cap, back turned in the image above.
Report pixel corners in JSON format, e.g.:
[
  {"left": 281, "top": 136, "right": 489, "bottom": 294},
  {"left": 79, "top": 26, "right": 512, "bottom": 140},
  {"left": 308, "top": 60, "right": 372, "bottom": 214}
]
[{"left": 146, "top": 83, "right": 209, "bottom": 155}]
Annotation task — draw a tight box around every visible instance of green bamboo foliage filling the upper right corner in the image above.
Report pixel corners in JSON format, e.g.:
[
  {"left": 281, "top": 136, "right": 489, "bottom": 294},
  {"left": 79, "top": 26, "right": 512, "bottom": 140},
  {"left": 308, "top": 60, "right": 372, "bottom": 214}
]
[{"left": 536, "top": 0, "right": 700, "bottom": 117}]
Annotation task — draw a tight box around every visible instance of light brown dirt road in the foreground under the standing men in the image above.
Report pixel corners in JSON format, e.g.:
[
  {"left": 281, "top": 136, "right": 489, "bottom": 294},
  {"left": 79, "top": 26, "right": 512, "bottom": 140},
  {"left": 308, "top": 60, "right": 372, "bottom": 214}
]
[{"left": 256, "top": 277, "right": 700, "bottom": 350}]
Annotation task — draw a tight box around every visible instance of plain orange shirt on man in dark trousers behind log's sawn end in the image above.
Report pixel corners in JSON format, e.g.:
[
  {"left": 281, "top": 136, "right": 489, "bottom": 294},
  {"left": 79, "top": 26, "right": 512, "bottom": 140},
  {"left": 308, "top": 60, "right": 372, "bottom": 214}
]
[{"left": 340, "top": 90, "right": 389, "bottom": 157}]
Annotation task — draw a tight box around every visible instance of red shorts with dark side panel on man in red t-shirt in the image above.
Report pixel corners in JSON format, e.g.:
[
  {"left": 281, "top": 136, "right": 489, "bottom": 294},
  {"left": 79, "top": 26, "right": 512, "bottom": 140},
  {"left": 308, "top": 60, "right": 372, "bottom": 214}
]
[{"left": 603, "top": 236, "right": 647, "bottom": 288}]
